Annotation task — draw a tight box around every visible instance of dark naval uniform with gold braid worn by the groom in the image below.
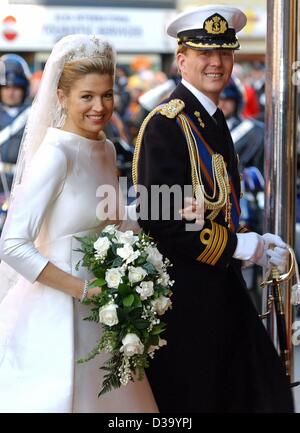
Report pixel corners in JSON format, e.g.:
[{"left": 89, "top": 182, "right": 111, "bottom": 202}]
[{"left": 133, "top": 82, "right": 293, "bottom": 413}]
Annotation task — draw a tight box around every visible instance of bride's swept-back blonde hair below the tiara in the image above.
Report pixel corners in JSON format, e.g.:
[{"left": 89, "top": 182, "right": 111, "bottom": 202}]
[{"left": 57, "top": 55, "right": 115, "bottom": 95}]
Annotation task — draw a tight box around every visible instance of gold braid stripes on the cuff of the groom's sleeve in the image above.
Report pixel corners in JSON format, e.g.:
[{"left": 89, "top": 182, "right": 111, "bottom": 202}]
[{"left": 197, "top": 221, "right": 228, "bottom": 265}]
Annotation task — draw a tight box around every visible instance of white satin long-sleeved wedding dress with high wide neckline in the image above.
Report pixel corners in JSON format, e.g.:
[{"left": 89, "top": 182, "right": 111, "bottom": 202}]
[{"left": 0, "top": 128, "right": 157, "bottom": 413}]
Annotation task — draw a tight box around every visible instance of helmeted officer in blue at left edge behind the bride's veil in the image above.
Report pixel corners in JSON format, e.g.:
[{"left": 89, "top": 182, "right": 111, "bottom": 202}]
[{"left": 0, "top": 54, "right": 31, "bottom": 231}]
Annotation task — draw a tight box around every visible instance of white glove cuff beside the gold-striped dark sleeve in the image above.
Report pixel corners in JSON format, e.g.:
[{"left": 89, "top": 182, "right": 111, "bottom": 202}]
[{"left": 233, "top": 232, "right": 265, "bottom": 263}]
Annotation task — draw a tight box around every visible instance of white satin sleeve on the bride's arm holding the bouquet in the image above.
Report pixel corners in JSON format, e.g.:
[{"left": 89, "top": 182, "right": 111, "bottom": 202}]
[{"left": 0, "top": 144, "right": 67, "bottom": 282}]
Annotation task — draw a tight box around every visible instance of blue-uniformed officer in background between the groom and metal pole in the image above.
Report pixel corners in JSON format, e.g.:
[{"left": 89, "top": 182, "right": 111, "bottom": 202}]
[{"left": 219, "top": 77, "right": 265, "bottom": 311}]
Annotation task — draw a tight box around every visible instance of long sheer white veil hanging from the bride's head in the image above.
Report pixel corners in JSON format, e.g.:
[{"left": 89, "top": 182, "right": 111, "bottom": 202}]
[{"left": 0, "top": 34, "right": 116, "bottom": 302}]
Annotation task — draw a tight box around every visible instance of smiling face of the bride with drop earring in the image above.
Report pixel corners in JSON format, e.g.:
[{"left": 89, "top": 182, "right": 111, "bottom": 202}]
[{"left": 58, "top": 73, "right": 114, "bottom": 140}]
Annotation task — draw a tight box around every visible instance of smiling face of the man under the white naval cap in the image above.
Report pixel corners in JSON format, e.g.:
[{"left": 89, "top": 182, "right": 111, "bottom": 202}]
[{"left": 177, "top": 48, "right": 234, "bottom": 104}]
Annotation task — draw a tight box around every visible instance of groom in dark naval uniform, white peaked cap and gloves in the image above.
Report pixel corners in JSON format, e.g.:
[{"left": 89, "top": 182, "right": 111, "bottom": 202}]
[{"left": 133, "top": 5, "right": 293, "bottom": 412}]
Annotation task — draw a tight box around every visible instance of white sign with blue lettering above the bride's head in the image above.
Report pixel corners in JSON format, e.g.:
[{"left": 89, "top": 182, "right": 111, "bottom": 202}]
[{"left": 0, "top": 5, "right": 176, "bottom": 53}]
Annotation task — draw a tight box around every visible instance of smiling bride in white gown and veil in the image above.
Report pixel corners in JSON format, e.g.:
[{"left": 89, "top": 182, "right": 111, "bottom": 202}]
[{"left": 0, "top": 35, "right": 162, "bottom": 412}]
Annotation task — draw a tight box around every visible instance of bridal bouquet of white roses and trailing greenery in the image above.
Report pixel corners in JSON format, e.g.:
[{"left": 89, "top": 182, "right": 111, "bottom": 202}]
[{"left": 77, "top": 225, "right": 174, "bottom": 397}]
